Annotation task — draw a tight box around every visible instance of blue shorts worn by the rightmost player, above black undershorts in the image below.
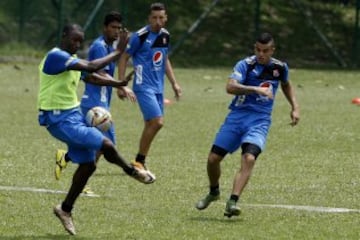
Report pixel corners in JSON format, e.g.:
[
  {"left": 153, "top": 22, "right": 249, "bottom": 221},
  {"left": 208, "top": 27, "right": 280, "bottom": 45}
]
[{"left": 214, "top": 111, "right": 271, "bottom": 153}]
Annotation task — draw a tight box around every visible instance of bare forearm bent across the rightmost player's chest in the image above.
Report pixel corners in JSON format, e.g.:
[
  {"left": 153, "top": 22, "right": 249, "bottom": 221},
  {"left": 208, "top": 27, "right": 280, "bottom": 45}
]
[{"left": 226, "top": 78, "right": 274, "bottom": 99}]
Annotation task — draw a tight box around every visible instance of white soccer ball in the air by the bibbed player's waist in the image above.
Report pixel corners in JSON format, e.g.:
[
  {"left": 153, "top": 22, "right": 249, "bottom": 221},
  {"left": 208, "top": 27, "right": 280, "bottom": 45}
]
[{"left": 86, "top": 107, "right": 112, "bottom": 132}]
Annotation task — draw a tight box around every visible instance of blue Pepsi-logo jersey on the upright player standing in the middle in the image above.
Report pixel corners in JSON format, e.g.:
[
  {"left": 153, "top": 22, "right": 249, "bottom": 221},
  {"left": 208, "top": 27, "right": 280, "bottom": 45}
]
[{"left": 126, "top": 26, "right": 170, "bottom": 93}]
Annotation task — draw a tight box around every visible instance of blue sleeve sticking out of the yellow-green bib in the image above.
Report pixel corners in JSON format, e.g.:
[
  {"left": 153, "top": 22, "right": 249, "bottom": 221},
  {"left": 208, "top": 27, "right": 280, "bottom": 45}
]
[{"left": 43, "top": 50, "right": 79, "bottom": 75}]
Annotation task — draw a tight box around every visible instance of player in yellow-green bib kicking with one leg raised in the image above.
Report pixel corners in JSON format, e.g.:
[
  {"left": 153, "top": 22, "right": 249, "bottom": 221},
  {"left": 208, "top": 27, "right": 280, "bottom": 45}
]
[{"left": 37, "top": 24, "right": 154, "bottom": 235}]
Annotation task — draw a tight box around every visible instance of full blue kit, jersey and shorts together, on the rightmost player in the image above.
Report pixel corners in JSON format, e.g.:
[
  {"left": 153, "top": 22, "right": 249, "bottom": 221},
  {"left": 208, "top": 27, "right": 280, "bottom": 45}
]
[{"left": 214, "top": 56, "right": 288, "bottom": 153}]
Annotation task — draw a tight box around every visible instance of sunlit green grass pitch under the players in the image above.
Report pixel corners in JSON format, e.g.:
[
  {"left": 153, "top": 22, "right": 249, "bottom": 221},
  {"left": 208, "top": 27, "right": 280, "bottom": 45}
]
[{"left": 0, "top": 64, "right": 360, "bottom": 240}]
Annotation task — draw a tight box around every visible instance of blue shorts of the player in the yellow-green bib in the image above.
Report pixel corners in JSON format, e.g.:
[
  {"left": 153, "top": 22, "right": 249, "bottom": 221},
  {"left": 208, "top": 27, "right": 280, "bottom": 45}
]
[{"left": 39, "top": 108, "right": 105, "bottom": 163}]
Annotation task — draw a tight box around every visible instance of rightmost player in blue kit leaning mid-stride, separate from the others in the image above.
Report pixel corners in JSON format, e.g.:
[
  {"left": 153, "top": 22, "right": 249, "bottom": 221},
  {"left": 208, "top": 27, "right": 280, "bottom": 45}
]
[{"left": 196, "top": 33, "right": 300, "bottom": 217}]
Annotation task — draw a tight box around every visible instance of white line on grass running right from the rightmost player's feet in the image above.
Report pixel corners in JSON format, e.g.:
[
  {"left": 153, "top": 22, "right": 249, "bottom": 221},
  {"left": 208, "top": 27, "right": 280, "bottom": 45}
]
[{"left": 242, "top": 204, "right": 360, "bottom": 213}]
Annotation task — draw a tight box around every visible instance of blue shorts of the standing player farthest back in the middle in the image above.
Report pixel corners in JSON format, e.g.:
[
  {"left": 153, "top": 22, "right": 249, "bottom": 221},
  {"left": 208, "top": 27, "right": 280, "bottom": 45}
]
[{"left": 135, "top": 92, "right": 164, "bottom": 121}]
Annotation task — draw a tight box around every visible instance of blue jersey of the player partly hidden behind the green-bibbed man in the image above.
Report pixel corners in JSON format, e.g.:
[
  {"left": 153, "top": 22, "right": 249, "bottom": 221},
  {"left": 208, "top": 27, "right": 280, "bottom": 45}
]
[{"left": 81, "top": 36, "right": 115, "bottom": 109}]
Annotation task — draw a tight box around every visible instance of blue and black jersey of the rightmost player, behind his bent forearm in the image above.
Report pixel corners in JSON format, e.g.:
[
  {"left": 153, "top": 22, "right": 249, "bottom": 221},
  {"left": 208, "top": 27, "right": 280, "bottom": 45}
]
[{"left": 229, "top": 56, "right": 289, "bottom": 115}]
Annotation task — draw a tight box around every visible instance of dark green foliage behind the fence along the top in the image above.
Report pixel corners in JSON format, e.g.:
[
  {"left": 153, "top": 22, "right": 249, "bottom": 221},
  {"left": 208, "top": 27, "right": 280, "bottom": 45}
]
[{"left": 0, "top": 0, "right": 360, "bottom": 67}]
